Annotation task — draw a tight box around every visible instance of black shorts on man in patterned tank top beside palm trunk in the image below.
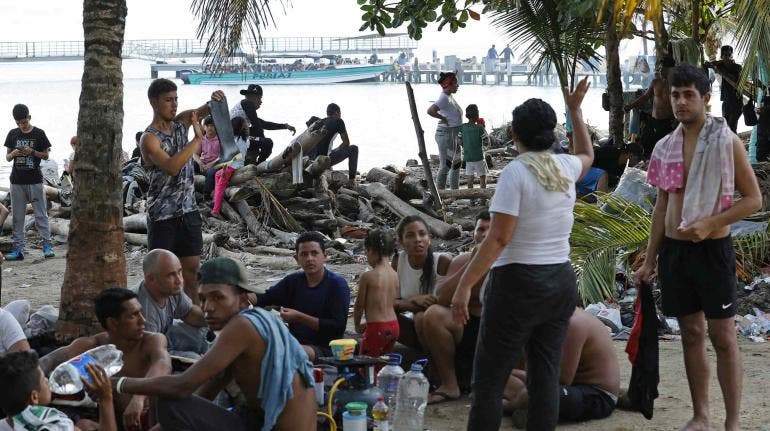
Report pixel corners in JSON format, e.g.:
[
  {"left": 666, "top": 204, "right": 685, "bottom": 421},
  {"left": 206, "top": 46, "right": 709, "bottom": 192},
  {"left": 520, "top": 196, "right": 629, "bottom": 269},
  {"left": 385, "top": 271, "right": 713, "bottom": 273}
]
[{"left": 147, "top": 210, "right": 203, "bottom": 257}]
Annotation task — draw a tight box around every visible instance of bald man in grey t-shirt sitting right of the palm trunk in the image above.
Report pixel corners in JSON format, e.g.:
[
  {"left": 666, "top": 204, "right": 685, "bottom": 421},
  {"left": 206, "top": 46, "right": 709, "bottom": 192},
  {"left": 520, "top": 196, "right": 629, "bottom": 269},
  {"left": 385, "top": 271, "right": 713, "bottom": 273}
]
[{"left": 132, "top": 248, "right": 208, "bottom": 357}]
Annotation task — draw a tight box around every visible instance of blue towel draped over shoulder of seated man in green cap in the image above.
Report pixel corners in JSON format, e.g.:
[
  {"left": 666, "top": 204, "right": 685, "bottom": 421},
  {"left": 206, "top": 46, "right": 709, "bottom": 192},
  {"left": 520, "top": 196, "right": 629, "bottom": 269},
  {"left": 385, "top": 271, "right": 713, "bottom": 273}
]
[{"left": 241, "top": 308, "right": 313, "bottom": 431}]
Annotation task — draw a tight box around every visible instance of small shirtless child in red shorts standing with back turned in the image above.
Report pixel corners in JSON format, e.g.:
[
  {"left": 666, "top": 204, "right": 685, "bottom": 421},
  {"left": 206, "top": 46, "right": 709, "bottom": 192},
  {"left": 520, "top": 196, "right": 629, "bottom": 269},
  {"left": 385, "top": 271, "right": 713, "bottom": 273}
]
[{"left": 353, "top": 229, "right": 398, "bottom": 357}]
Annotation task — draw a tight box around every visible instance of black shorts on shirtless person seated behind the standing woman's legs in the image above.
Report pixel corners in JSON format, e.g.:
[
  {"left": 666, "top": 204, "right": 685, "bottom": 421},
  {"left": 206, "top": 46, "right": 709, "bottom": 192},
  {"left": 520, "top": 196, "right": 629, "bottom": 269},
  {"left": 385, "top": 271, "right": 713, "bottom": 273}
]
[{"left": 559, "top": 385, "right": 616, "bottom": 421}]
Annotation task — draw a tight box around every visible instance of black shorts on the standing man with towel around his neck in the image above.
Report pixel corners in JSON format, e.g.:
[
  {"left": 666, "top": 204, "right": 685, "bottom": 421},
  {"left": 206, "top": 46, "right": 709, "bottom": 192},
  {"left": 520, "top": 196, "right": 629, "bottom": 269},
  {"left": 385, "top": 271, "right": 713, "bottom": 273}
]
[{"left": 658, "top": 236, "right": 738, "bottom": 319}]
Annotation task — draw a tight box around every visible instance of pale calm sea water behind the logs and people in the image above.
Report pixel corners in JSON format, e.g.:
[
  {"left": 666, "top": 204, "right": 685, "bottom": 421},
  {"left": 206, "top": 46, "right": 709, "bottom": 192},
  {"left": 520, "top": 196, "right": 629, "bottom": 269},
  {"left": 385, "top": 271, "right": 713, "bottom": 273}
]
[{"left": 0, "top": 60, "right": 736, "bottom": 185}]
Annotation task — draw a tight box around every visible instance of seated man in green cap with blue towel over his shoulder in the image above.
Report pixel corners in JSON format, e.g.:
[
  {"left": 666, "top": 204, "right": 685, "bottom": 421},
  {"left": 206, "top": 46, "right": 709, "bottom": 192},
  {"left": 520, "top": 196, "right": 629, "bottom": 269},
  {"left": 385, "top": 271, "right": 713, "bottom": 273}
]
[{"left": 115, "top": 257, "right": 316, "bottom": 431}]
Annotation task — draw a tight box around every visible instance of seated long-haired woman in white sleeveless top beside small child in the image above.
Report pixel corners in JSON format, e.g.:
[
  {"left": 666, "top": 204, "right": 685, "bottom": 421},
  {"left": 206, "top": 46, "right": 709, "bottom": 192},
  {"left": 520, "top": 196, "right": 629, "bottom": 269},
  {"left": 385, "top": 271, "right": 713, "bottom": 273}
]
[{"left": 390, "top": 216, "right": 452, "bottom": 349}]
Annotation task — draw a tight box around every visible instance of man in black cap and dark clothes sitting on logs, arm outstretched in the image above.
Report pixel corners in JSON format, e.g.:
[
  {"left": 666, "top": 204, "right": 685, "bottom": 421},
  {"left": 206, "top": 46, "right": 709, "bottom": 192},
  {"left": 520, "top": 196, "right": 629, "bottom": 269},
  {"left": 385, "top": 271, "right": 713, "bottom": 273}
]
[{"left": 230, "top": 84, "right": 297, "bottom": 165}]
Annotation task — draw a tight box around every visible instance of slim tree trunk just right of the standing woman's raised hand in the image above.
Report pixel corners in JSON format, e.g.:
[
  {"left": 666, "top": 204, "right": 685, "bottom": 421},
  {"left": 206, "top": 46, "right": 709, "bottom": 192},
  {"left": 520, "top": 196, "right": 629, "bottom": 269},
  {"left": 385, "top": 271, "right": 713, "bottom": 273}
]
[{"left": 605, "top": 14, "right": 626, "bottom": 148}]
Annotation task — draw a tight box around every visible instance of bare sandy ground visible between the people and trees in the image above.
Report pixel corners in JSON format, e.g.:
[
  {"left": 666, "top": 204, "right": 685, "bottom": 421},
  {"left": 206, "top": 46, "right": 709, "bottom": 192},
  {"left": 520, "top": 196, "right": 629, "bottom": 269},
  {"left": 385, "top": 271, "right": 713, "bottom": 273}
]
[{"left": 2, "top": 245, "right": 770, "bottom": 431}]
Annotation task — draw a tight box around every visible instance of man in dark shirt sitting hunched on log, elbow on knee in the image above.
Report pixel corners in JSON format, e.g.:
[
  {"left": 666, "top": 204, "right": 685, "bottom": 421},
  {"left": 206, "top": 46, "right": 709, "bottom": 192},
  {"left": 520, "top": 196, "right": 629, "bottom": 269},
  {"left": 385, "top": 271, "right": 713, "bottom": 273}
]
[{"left": 308, "top": 103, "right": 358, "bottom": 187}]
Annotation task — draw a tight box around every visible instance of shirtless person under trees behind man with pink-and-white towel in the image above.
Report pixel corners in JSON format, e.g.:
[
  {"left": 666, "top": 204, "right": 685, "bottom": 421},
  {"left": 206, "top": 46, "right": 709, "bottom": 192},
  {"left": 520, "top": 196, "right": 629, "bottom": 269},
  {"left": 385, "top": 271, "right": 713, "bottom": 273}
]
[{"left": 625, "top": 57, "right": 676, "bottom": 159}]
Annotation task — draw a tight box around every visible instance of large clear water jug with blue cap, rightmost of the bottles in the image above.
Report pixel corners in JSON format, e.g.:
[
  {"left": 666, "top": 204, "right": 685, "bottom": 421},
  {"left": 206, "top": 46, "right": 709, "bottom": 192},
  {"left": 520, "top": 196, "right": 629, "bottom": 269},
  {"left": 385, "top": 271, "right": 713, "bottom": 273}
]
[{"left": 393, "top": 359, "right": 430, "bottom": 431}]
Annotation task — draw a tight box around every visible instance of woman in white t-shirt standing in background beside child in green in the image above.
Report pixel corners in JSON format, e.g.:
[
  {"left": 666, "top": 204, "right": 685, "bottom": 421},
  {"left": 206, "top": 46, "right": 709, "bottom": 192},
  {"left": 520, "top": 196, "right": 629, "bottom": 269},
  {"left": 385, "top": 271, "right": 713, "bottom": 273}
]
[{"left": 428, "top": 72, "right": 463, "bottom": 189}]
